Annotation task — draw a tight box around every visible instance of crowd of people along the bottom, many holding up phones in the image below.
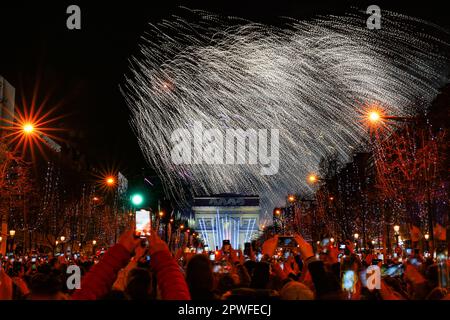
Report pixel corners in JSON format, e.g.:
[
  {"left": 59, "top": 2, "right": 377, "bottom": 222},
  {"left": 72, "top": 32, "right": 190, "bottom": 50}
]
[{"left": 0, "top": 230, "right": 450, "bottom": 301}]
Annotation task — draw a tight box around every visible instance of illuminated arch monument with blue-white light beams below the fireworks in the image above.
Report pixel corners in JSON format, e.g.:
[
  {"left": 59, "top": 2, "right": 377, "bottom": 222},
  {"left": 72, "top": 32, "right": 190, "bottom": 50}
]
[{"left": 192, "top": 194, "right": 260, "bottom": 250}]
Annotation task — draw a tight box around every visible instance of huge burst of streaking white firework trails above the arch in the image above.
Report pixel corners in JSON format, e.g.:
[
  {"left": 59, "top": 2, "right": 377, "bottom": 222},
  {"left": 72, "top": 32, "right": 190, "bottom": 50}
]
[{"left": 123, "top": 10, "right": 447, "bottom": 218}]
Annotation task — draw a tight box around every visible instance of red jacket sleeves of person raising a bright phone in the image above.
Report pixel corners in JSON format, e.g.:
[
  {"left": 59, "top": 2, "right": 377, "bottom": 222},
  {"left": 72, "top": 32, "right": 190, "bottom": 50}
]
[{"left": 72, "top": 244, "right": 190, "bottom": 300}]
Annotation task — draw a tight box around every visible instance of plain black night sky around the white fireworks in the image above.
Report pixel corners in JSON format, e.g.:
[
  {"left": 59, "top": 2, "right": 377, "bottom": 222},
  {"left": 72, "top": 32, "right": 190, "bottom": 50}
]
[{"left": 0, "top": 0, "right": 450, "bottom": 182}]
